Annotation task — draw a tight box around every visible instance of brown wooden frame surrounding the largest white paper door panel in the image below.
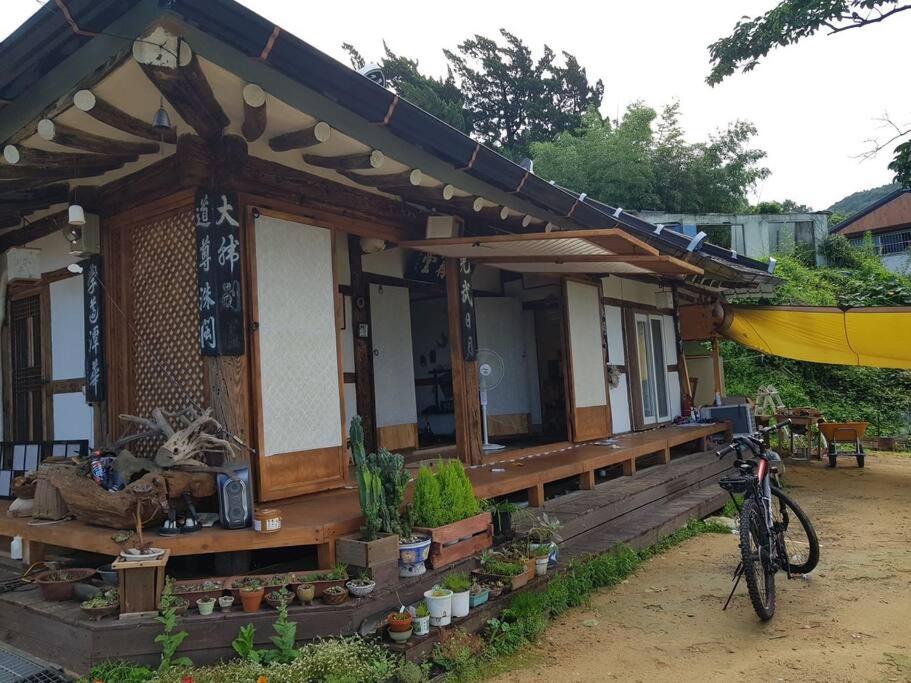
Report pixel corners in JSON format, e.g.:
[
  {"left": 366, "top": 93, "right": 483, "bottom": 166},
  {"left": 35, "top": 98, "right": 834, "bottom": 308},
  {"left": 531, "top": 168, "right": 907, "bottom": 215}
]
[{"left": 241, "top": 203, "right": 348, "bottom": 501}]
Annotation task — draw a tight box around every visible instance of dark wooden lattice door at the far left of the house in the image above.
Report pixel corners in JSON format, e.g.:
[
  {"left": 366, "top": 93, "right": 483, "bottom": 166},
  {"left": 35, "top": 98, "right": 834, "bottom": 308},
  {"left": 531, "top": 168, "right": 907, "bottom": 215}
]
[{"left": 9, "top": 294, "right": 45, "bottom": 441}]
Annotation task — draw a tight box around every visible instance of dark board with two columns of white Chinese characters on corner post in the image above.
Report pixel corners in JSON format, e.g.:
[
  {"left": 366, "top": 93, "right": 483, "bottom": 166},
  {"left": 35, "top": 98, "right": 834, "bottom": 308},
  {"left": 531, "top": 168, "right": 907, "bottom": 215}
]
[{"left": 196, "top": 189, "right": 244, "bottom": 356}]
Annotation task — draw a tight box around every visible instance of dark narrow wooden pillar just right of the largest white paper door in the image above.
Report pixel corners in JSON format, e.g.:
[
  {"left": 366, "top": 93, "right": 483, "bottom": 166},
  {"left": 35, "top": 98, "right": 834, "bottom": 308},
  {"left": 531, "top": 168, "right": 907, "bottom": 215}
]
[{"left": 348, "top": 235, "right": 376, "bottom": 453}]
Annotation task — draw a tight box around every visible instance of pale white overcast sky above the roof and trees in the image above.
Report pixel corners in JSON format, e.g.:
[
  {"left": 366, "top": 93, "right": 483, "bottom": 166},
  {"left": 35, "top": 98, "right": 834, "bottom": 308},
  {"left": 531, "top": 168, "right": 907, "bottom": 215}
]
[{"left": 0, "top": 0, "right": 911, "bottom": 209}]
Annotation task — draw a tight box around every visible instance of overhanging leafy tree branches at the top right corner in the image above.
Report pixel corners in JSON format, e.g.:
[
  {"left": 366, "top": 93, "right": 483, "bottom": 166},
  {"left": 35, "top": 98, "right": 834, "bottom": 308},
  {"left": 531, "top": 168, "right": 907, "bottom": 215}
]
[{"left": 706, "top": 0, "right": 911, "bottom": 187}]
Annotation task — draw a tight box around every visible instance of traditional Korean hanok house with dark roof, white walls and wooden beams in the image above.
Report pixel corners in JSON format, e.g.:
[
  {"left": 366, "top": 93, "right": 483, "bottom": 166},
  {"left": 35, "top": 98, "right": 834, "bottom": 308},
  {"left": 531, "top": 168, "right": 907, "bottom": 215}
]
[{"left": 0, "top": 0, "right": 774, "bottom": 672}]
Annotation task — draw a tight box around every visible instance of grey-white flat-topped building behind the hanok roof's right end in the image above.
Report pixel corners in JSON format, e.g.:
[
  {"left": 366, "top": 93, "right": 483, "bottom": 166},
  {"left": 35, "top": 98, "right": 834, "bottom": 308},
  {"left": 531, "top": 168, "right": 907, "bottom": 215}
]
[{"left": 638, "top": 211, "right": 829, "bottom": 263}]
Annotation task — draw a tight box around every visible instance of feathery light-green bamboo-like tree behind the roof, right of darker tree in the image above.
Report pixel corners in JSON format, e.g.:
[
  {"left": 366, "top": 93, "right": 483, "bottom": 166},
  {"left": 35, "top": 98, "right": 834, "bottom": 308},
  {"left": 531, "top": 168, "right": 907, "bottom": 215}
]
[{"left": 532, "top": 102, "right": 768, "bottom": 213}]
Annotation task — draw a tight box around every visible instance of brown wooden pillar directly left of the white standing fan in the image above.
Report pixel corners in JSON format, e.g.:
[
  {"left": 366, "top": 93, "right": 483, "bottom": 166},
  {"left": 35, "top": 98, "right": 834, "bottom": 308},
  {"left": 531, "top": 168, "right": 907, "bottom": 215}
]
[{"left": 446, "top": 258, "right": 482, "bottom": 465}]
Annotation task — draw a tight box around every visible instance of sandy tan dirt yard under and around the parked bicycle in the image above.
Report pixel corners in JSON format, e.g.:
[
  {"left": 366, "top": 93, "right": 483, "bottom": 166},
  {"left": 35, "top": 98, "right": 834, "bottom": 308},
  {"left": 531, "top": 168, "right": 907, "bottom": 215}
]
[{"left": 497, "top": 454, "right": 911, "bottom": 683}]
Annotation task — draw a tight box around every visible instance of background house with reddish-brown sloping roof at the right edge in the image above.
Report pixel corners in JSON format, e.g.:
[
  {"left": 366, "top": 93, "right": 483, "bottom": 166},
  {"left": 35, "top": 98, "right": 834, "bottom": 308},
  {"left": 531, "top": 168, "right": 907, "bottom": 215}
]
[{"left": 832, "top": 189, "right": 911, "bottom": 273}]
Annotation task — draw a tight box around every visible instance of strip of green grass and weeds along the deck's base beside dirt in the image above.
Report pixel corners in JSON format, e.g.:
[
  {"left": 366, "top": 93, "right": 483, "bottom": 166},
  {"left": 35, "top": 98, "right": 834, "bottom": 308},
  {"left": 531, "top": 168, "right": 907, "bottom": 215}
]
[{"left": 442, "top": 519, "right": 731, "bottom": 681}]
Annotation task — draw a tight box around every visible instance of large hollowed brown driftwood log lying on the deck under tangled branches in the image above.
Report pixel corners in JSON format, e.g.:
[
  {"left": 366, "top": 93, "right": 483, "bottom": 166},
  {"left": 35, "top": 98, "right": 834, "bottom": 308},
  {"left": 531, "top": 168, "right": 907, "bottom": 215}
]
[{"left": 41, "top": 465, "right": 216, "bottom": 529}]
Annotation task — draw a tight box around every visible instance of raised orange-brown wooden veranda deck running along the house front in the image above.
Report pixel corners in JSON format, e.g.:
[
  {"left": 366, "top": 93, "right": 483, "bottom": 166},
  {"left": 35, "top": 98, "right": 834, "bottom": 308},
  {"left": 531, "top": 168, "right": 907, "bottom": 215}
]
[{"left": 0, "top": 423, "right": 728, "bottom": 568}]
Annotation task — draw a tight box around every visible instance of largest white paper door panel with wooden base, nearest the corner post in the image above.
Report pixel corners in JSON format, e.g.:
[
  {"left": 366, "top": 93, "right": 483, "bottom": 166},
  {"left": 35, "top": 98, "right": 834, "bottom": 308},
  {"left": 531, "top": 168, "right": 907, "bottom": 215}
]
[{"left": 251, "top": 215, "right": 347, "bottom": 500}]
